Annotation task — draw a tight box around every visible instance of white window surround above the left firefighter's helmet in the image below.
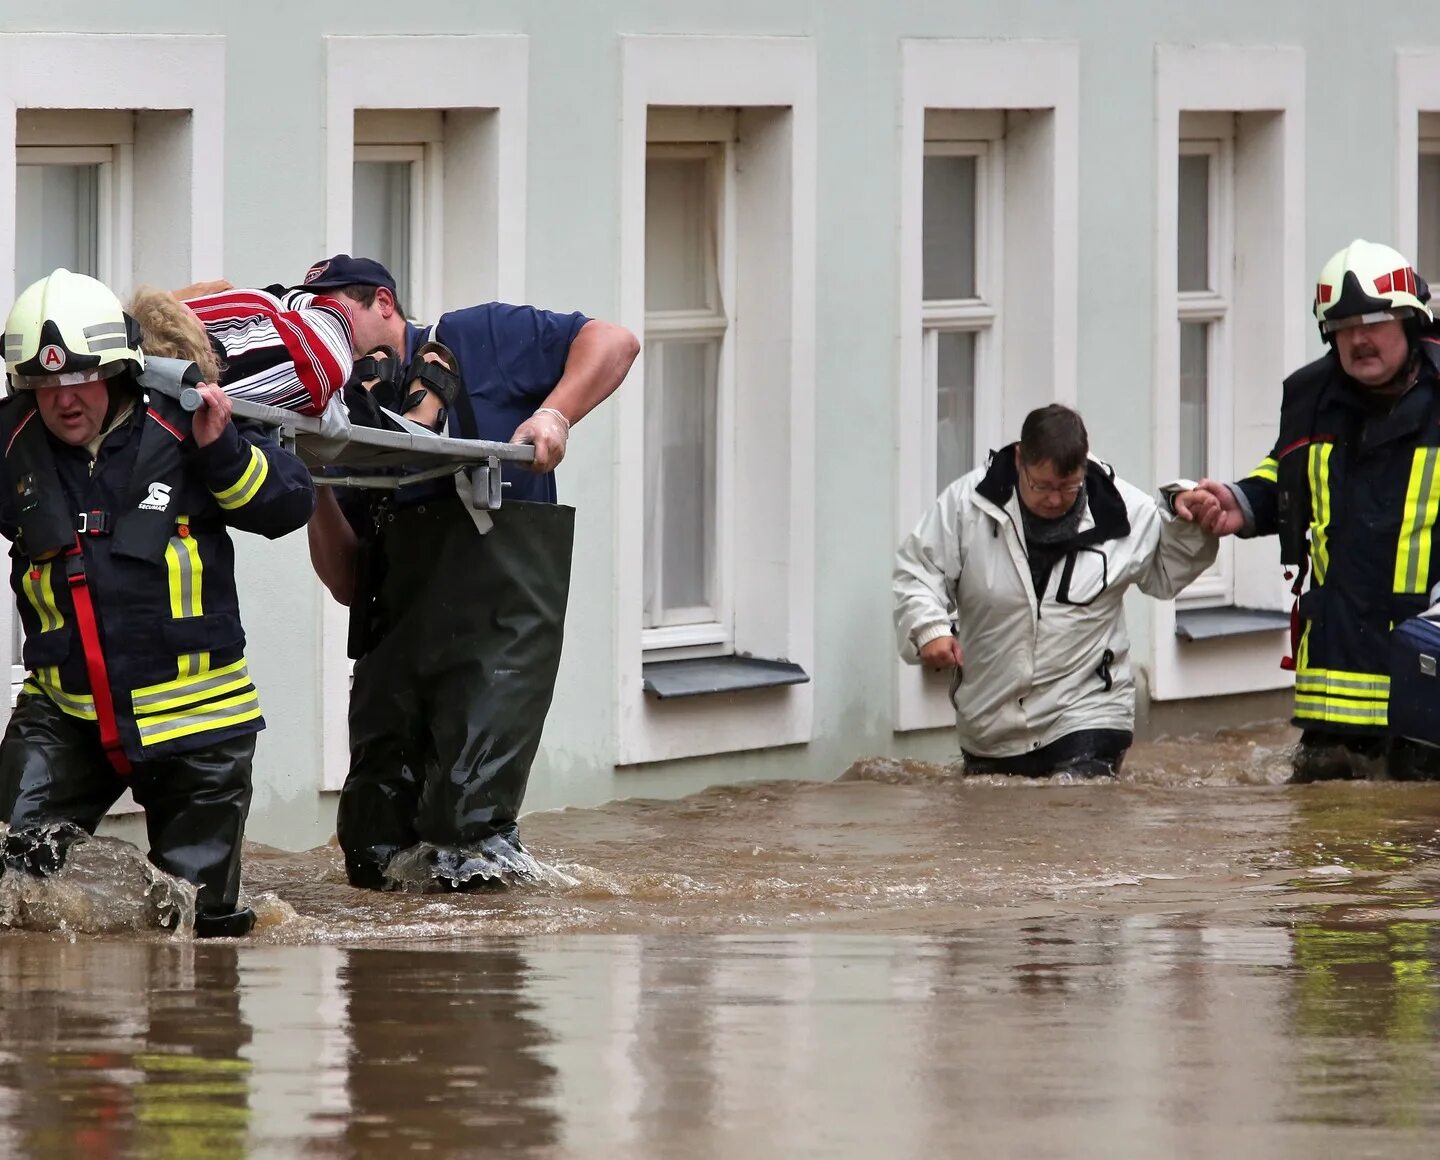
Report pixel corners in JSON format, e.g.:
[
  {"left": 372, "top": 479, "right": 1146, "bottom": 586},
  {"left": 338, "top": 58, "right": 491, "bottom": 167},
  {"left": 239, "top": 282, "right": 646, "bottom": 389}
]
[{"left": 0, "top": 33, "right": 225, "bottom": 812}]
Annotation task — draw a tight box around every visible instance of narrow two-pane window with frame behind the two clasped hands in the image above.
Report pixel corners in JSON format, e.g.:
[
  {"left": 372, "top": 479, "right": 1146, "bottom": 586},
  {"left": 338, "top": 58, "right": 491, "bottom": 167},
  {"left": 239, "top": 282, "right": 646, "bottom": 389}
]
[{"left": 1174, "top": 112, "right": 1232, "bottom": 606}]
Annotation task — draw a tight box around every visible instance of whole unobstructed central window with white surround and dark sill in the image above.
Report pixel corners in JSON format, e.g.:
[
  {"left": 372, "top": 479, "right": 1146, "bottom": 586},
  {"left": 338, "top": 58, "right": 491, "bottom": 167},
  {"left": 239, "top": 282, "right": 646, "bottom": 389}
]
[{"left": 612, "top": 36, "right": 815, "bottom": 766}]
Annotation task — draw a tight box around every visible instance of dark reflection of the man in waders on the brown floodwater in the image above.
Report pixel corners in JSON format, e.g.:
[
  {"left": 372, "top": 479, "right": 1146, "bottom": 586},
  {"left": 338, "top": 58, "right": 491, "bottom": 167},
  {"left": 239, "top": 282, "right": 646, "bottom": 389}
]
[{"left": 340, "top": 950, "right": 558, "bottom": 1154}]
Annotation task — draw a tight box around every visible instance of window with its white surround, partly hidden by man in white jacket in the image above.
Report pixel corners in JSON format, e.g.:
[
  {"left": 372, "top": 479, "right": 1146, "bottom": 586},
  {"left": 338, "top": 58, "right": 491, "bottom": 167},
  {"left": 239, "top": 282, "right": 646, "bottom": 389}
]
[{"left": 893, "top": 39, "right": 1080, "bottom": 731}]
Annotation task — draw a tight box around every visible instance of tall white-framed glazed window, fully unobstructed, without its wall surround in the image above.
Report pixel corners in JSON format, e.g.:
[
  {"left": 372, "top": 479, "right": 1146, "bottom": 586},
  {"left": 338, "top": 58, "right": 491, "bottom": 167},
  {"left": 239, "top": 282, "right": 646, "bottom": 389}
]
[{"left": 644, "top": 133, "right": 734, "bottom": 652}]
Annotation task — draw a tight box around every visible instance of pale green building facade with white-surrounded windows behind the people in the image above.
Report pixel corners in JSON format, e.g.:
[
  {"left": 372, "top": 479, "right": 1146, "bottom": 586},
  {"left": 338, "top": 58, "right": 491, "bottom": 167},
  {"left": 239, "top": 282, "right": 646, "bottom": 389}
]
[{"left": 0, "top": 0, "right": 1440, "bottom": 846}]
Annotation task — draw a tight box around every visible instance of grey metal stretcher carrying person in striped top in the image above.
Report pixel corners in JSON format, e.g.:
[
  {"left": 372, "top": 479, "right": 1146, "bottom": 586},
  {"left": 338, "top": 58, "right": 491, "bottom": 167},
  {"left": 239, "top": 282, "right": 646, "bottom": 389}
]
[{"left": 141, "top": 357, "right": 536, "bottom": 511}]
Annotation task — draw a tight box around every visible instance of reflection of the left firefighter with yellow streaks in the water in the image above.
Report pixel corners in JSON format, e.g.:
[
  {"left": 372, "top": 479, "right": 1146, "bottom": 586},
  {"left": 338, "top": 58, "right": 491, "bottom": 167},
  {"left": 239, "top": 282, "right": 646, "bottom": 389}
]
[{"left": 0, "top": 940, "right": 251, "bottom": 1160}]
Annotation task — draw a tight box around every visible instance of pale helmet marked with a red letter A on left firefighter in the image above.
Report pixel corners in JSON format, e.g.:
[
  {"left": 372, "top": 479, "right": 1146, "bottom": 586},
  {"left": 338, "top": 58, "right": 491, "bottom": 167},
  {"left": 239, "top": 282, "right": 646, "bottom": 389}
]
[{"left": 4, "top": 269, "right": 145, "bottom": 390}]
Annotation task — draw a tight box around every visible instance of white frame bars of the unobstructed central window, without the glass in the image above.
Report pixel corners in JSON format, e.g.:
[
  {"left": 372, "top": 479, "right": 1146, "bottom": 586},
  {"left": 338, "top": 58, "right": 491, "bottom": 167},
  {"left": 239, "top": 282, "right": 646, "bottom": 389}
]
[{"left": 641, "top": 138, "right": 736, "bottom": 659}]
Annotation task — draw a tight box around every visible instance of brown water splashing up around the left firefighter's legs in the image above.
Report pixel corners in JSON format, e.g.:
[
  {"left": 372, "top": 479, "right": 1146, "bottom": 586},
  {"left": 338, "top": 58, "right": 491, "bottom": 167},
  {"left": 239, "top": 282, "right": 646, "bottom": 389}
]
[{"left": 0, "top": 826, "right": 196, "bottom": 934}]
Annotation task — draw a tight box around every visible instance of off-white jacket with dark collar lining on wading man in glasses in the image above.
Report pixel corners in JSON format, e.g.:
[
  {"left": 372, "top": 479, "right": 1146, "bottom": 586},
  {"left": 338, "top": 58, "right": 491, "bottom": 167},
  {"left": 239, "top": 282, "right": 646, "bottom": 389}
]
[{"left": 894, "top": 445, "right": 1218, "bottom": 757}]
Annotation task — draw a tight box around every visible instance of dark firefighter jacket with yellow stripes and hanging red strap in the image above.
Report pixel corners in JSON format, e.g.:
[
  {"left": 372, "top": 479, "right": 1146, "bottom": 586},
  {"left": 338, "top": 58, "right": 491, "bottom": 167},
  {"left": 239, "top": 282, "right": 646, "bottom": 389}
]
[{"left": 0, "top": 384, "right": 315, "bottom": 771}]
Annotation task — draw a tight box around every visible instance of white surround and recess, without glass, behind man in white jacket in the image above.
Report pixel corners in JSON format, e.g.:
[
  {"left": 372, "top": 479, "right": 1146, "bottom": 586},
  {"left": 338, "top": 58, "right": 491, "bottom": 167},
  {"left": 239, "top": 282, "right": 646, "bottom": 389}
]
[{"left": 894, "top": 40, "right": 1080, "bottom": 731}]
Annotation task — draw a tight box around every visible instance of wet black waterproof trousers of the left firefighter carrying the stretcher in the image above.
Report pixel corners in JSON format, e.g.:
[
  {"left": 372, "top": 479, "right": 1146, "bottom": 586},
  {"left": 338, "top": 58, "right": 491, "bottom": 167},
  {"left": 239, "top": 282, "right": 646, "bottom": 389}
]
[{"left": 0, "top": 694, "right": 255, "bottom": 935}]
